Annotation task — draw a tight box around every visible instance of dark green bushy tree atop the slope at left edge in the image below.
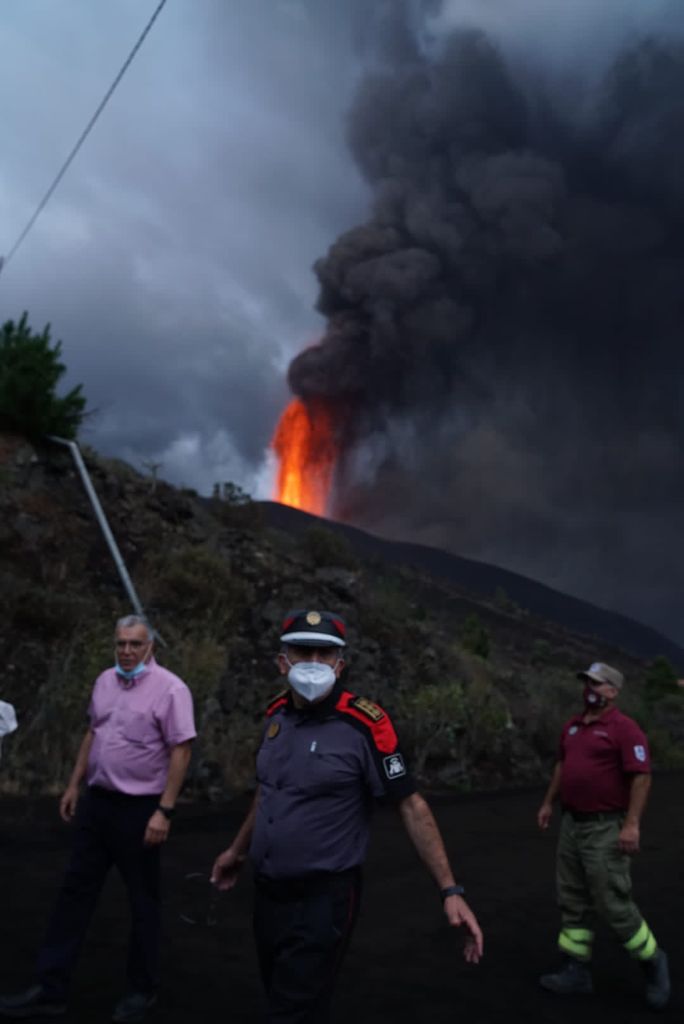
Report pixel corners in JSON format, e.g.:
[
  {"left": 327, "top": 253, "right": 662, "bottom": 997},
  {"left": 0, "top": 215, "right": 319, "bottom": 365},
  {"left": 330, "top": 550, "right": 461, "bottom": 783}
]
[{"left": 0, "top": 312, "right": 86, "bottom": 440}]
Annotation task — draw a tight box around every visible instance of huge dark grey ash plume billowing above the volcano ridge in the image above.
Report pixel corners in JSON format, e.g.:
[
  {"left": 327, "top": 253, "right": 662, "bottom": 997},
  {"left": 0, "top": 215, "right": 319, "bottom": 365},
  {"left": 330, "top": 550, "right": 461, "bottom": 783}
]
[{"left": 289, "top": 5, "right": 684, "bottom": 640}]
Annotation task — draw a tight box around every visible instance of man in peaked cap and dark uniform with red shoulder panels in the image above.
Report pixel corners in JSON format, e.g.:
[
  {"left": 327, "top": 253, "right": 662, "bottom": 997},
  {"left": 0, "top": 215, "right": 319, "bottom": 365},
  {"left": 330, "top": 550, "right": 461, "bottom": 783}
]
[{"left": 212, "top": 610, "right": 482, "bottom": 1024}]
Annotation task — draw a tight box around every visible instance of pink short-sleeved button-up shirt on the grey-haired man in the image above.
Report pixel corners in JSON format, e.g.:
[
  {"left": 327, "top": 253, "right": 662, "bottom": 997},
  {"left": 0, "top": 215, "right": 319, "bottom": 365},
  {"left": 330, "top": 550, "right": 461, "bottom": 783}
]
[{"left": 86, "top": 658, "right": 197, "bottom": 796}]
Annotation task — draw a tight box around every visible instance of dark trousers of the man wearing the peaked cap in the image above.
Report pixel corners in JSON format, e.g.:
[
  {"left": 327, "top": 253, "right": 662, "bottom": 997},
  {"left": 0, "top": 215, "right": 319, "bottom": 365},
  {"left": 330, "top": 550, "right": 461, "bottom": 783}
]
[{"left": 254, "top": 868, "right": 361, "bottom": 1024}]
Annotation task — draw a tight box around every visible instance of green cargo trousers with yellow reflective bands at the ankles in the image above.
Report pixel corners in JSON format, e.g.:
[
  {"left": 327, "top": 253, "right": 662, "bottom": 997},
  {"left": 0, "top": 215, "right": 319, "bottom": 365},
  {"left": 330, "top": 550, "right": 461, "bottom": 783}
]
[{"left": 556, "top": 811, "right": 657, "bottom": 962}]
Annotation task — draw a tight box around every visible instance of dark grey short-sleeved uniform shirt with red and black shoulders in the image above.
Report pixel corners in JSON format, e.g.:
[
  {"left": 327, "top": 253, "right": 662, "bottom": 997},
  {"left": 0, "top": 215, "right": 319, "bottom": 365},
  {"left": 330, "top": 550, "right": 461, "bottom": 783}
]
[{"left": 250, "top": 684, "right": 416, "bottom": 880}]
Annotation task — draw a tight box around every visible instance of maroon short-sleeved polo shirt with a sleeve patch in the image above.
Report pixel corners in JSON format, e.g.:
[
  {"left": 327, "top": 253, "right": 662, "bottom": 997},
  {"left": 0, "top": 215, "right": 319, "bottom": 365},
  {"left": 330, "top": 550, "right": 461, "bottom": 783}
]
[{"left": 560, "top": 708, "right": 650, "bottom": 813}]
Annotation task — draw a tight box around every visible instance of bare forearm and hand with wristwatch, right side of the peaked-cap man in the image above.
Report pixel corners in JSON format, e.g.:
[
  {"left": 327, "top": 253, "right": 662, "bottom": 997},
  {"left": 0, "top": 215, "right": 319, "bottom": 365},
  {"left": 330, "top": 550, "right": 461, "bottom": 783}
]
[{"left": 399, "top": 793, "right": 482, "bottom": 964}]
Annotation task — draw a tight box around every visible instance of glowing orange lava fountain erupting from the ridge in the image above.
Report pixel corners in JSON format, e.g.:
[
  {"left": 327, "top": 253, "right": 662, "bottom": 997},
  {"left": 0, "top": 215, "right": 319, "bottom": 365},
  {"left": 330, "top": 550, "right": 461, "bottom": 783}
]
[{"left": 271, "top": 398, "right": 337, "bottom": 515}]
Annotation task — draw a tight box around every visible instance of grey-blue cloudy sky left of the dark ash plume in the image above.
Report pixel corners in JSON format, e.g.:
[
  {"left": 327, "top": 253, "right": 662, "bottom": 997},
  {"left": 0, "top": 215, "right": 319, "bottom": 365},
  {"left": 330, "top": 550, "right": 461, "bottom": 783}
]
[{"left": 0, "top": 0, "right": 367, "bottom": 497}]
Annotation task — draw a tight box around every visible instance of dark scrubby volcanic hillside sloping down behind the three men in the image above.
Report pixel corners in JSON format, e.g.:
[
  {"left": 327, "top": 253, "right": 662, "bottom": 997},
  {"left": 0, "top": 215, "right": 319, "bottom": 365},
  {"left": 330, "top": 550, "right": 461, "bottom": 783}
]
[{"left": 0, "top": 435, "right": 684, "bottom": 798}]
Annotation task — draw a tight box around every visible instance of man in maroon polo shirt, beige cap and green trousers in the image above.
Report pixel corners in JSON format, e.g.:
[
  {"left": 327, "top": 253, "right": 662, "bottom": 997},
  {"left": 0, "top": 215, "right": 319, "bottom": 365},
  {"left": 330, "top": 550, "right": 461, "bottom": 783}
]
[{"left": 537, "top": 662, "right": 670, "bottom": 1009}]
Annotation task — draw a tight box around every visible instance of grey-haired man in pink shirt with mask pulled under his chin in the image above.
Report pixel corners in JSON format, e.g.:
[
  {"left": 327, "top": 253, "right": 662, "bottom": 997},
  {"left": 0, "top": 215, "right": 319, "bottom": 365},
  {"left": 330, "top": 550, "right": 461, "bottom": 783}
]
[{"left": 0, "top": 615, "right": 196, "bottom": 1024}]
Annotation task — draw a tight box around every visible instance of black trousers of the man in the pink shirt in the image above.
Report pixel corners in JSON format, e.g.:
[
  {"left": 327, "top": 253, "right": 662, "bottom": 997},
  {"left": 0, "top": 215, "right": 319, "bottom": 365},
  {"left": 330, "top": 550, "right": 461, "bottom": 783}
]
[{"left": 37, "top": 786, "right": 160, "bottom": 999}]
